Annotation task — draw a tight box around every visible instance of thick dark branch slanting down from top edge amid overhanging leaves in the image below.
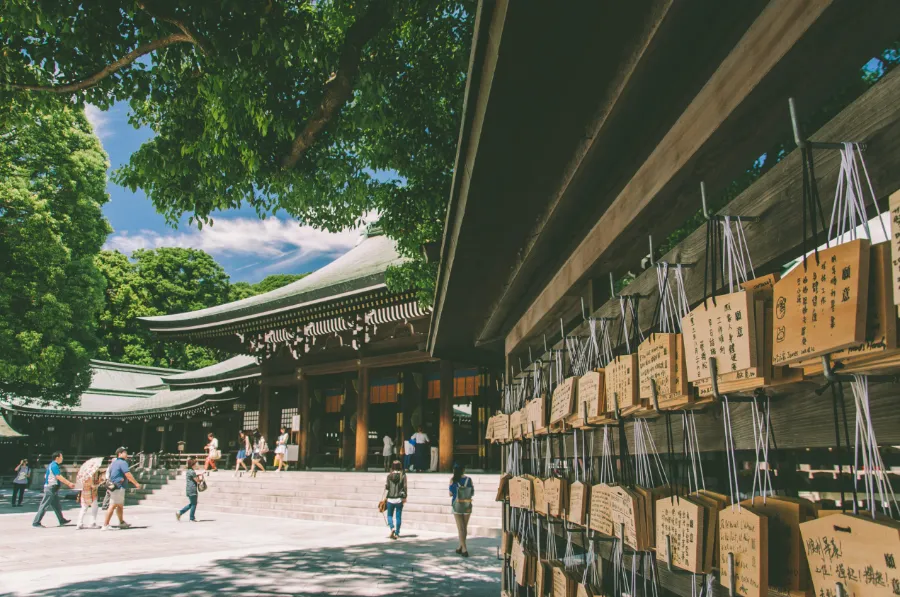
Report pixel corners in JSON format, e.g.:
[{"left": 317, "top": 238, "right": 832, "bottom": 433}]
[{"left": 282, "top": 0, "right": 391, "bottom": 168}]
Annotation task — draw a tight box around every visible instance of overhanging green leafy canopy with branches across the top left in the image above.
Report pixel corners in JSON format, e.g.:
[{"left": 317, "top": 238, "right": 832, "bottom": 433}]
[{"left": 0, "top": 0, "right": 475, "bottom": 300}]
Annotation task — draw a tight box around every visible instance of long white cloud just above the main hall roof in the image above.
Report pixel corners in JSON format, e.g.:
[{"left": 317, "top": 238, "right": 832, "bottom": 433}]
[{"left": 104, "top": 218, "right": 370, "bottom": 272}]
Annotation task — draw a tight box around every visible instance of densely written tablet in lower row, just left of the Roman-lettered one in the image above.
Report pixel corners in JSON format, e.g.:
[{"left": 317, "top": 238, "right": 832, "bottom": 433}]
[{"left": 656, "top": 497, "right": 706, "bottom": 574}]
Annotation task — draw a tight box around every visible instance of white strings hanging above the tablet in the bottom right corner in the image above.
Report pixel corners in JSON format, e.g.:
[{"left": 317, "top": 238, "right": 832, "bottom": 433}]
[{"left": 850, "top": 375, "right": 897, "bottom": 519}]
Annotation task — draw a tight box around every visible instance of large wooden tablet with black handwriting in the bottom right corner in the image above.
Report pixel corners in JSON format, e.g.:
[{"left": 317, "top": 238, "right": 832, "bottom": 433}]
[{"left": 800, "top": 514, "right": 900, "bottom": 597}]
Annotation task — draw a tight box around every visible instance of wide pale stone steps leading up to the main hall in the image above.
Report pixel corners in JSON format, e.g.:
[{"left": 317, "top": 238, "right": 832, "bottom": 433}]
[{"left": 128, "top": 471, "right": 502, "bottom": 537}]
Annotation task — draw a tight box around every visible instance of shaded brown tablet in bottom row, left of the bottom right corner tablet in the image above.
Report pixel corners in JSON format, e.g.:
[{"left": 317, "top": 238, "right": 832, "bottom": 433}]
[{"left": 741, "top": 497, "right": 816, "bottom": 591}]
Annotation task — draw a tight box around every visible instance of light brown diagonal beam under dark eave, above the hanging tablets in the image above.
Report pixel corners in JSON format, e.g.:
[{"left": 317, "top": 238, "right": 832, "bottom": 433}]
[{"left": 506, "top": 0, "right": 831, "bottom": 354}]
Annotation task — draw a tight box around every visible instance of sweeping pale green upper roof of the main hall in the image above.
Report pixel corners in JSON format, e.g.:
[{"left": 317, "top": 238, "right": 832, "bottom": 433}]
[{"left": 140, "top": 231, "right": 404, "bottom": 334}]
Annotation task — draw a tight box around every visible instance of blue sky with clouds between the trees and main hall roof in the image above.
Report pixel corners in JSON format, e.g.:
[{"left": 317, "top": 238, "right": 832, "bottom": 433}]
[{"left": 86, "top": 103, "right": 370, "bottom": 282}]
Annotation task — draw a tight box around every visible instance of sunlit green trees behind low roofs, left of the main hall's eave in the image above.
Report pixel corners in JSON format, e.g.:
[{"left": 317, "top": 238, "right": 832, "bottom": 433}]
[{"left": 97, "top": 248, "right": 230, "bottom": 369}]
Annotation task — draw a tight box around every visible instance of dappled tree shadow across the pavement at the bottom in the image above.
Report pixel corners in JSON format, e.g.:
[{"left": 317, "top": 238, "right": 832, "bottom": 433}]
[{"left": 21, "top": 539, "right": 500, "bottom": 597}]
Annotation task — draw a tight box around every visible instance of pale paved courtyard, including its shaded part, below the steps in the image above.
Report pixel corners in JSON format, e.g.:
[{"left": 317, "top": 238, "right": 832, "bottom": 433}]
[{"left": 0, "top": 491, "right": 500, "bottom": 597}]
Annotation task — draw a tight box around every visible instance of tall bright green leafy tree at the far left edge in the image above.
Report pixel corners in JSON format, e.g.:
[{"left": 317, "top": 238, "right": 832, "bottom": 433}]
[{"left": 0, "top": 104, "right": 111, "bottom": 404}]
